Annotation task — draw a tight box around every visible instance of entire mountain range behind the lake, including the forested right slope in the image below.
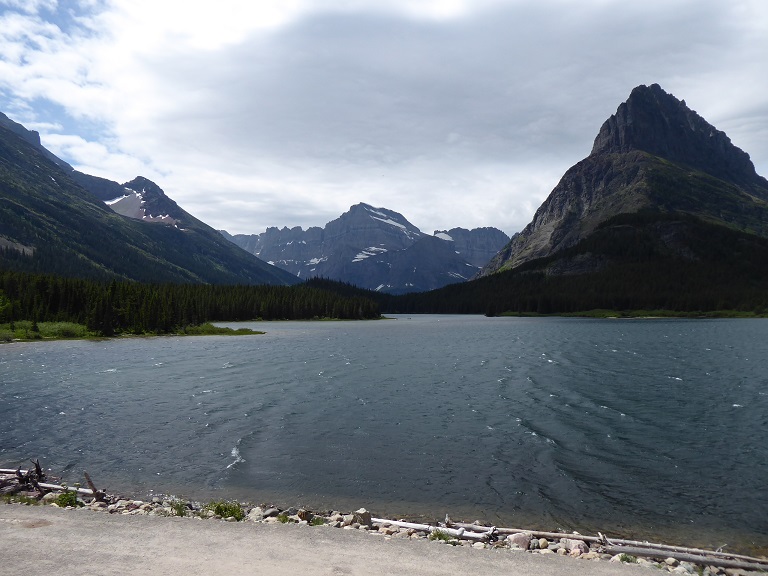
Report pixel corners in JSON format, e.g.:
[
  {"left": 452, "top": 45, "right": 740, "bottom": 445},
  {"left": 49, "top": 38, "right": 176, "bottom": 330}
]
[{"left": 0, "top": 84, "right": 768, "bottom": 314}]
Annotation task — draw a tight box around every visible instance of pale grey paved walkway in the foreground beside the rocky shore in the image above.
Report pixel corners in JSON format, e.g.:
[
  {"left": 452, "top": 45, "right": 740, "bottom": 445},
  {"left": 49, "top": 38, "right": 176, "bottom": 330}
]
[{"left": 0, "top": 504, "right": 647, "bottom": 576}]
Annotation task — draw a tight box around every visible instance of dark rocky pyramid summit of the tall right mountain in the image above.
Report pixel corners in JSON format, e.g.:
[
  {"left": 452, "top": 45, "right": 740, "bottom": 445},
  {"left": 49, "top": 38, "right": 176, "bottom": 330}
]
[{"left": 591, "top": 84, "right": 762, "bottom": 184}]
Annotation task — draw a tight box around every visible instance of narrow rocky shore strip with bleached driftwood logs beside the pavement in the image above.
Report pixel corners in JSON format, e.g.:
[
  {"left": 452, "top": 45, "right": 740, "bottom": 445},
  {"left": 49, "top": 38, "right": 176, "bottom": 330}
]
[{"left": 0, "top": 470, "right": 768, "bottom": 576}]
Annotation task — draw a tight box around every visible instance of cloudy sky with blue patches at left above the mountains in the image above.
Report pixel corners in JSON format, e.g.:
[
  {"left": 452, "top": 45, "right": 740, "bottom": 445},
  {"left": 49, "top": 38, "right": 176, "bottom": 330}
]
[{"left": 0, "top": 0, "right": 768, "bottom": 234}]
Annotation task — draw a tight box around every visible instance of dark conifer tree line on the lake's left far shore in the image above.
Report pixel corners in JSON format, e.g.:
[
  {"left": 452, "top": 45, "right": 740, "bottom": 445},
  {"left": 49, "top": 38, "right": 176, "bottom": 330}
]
[{"left": 0, "top": 271, "right": 380, "bottom": 336}]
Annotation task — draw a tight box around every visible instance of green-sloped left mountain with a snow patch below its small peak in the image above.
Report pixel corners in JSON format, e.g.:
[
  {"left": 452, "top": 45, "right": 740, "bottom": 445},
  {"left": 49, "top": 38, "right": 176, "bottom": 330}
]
[{"left": 0, "top": 115, "right": 297, "bottom": 285}]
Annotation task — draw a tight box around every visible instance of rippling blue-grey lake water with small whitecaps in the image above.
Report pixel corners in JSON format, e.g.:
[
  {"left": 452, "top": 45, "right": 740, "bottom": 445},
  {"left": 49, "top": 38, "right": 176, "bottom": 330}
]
[{"left": 0, "top": 316, "right": 768, "bottom": 549}]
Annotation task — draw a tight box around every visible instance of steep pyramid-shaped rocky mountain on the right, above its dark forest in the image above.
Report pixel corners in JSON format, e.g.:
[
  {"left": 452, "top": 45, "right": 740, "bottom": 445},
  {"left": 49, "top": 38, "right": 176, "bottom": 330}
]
[{"left": 480, "top": 84, "right": 768, "bottom": 276}]
